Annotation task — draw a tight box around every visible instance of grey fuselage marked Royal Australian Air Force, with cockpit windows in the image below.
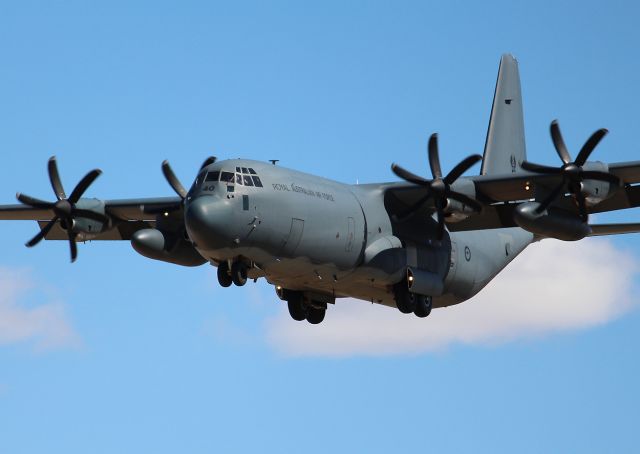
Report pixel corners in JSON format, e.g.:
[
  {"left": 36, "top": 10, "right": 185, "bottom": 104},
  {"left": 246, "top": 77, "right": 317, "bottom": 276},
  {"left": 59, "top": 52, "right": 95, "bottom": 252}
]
[{"left": 185, "top": 159, "right": 533, "bottom": 307}]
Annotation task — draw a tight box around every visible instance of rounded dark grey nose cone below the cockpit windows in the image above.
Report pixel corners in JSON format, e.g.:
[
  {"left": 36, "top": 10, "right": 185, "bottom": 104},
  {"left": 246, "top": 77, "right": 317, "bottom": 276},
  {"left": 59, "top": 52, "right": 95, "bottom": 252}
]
[{"left": 184, "top": 197, "right": 226, "bottom": 249}]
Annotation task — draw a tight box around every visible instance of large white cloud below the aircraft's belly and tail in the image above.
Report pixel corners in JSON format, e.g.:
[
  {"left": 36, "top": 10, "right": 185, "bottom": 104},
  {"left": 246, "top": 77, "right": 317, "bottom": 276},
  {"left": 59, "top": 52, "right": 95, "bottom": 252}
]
[{"left": 266, "top": 239, "right": 638, "bottom": 356}]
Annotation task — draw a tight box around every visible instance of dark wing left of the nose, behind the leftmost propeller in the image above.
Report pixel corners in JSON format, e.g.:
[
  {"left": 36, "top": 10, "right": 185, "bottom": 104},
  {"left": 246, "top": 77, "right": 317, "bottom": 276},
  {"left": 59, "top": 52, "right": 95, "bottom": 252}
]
[{"left": 0, "top": 197, "right": 182, "bottom": 241}]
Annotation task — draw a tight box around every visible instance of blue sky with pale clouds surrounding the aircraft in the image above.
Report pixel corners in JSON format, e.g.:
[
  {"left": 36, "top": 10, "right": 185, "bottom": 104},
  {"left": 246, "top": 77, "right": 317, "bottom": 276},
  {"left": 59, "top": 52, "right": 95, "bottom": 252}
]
[{"left": 0, "top": 1, "right": 640, "bottom": 453}]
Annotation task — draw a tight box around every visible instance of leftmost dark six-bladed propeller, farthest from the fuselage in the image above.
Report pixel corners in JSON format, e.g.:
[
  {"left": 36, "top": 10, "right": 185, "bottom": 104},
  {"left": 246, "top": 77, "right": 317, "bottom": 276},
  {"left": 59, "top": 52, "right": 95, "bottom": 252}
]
[{"left": 16, "top": 156, "right": 109, "bottom": 262}]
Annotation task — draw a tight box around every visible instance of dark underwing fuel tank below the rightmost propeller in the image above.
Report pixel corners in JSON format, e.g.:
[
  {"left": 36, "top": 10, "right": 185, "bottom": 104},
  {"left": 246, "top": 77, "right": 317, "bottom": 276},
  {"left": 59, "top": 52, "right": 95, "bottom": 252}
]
[{"left": 513, "top": 202, "right": 591, "bottom": 241}]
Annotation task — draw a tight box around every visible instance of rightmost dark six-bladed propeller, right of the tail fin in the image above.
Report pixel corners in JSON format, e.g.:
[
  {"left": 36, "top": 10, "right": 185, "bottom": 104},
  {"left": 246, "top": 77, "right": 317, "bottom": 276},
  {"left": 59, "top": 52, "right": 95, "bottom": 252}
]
[{"left": 522, "top": 120, "right": 620, "bottom": 222}]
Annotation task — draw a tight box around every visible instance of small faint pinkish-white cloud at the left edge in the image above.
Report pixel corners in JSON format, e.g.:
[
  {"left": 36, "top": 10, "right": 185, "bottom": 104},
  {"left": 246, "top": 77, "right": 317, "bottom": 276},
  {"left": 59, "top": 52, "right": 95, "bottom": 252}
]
[{"left": 0, "top": 268, "right": 79, "bottom": 350}]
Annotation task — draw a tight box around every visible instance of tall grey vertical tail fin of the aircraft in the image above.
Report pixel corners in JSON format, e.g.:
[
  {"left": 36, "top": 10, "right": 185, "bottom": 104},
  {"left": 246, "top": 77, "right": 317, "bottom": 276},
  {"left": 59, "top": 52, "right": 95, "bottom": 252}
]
[{"left": 480, "top": 54, "right": 527, "bottom": 175}]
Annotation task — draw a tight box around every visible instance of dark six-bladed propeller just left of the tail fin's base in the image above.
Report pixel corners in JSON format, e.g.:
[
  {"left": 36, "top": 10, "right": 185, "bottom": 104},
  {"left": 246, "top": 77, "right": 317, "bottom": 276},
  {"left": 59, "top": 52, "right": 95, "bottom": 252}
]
[{"left": 391, "top": 134, "right": 482, "bottom": 240}]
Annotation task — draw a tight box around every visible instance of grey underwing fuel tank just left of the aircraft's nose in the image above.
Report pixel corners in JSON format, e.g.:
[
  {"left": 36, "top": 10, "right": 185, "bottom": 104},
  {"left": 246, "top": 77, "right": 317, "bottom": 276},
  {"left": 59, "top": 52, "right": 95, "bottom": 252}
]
[{"left": 131, "top": 229, "right": 207, "bottom": 266}]
